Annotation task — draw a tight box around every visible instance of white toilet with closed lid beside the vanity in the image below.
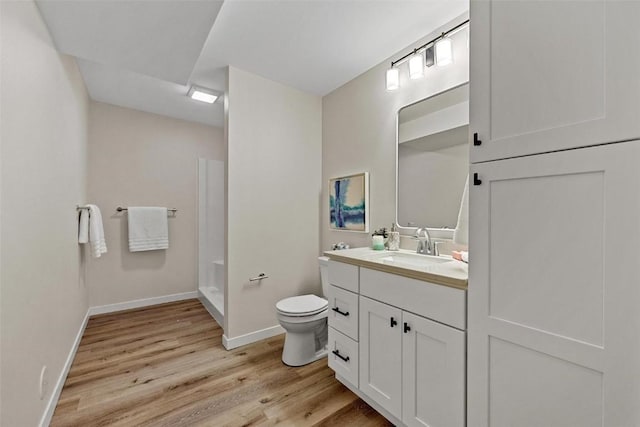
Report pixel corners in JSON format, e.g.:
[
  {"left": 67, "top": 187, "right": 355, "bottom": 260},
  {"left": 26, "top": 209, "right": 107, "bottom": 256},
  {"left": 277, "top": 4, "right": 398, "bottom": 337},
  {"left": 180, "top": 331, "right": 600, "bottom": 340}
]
[{"left": 276, "top": 257, "right": 329, "bottom": 366}]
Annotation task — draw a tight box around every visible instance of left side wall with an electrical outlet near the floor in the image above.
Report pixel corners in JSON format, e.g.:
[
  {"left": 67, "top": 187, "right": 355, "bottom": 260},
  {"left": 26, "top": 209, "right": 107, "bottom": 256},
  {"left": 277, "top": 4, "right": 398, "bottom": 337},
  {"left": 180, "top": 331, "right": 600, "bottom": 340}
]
[{"left": 0, "top": 1, "right": 88, "bottom": 426}]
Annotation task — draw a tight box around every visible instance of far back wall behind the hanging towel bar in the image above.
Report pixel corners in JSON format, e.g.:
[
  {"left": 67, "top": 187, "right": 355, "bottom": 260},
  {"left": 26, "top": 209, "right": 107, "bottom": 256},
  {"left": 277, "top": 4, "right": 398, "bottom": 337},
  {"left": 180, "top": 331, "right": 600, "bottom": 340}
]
[{"left": 88, "top": 102, "right": 224, "bottom": 307}]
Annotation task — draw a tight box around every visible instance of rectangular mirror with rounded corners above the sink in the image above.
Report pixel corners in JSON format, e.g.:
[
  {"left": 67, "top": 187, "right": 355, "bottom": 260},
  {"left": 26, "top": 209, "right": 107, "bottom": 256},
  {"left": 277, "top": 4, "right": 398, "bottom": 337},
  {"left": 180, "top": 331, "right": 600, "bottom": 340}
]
[{"left": 396, "top": 83, "right": 469, "bottom": 238}]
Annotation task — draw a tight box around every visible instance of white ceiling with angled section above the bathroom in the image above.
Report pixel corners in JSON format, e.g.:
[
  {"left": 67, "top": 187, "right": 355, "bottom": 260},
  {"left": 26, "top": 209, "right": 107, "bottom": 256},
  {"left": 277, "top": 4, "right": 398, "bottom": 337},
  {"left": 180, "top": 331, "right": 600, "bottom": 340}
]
[{"left": 36, "top": 0, "right": 468, "bottom": 126}]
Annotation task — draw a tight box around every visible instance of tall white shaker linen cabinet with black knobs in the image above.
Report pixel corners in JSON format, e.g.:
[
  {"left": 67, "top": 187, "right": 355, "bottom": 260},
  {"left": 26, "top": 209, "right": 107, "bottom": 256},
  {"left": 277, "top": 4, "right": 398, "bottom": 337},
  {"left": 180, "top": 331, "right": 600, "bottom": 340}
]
[{"left": 467, "top": 0, "right": 640, "bottom": 427}]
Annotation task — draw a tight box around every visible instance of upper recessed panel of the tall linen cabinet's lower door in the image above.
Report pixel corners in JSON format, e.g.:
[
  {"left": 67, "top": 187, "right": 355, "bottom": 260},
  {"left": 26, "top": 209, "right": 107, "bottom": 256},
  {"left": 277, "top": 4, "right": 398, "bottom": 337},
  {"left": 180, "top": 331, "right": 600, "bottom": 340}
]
[{"left": 487, "top": 167, "right": 605, "bottom": 346}]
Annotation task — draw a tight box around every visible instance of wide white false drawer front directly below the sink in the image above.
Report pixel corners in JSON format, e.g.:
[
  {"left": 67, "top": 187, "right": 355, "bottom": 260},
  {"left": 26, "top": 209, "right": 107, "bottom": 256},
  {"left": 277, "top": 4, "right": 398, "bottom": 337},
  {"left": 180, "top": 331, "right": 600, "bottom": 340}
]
[{"left": 360, "top": 268, "right": 467, "bottom": 330}]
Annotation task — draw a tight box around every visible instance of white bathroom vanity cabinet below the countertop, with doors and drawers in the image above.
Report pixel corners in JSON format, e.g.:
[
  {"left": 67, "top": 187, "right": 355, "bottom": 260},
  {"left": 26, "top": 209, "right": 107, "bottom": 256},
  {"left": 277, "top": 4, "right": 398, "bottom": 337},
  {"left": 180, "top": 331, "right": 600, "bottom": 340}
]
[{"left": 329, "top": 262, "right": 466, "bottom": 427}]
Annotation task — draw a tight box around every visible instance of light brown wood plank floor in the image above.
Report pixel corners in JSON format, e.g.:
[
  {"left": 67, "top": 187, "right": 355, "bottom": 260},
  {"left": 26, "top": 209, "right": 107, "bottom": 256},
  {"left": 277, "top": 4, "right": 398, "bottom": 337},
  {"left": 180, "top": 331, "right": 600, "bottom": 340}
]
[{"left": 51, "top": 300, "right": 391, "bottom": 427}]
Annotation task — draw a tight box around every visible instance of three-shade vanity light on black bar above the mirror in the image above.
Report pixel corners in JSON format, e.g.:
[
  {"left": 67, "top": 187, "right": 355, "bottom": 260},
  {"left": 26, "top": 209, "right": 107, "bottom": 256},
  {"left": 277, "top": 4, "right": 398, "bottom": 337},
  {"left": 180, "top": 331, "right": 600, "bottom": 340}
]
[{"left": 386, "top": 19, "right": 469, "bottom": 90}]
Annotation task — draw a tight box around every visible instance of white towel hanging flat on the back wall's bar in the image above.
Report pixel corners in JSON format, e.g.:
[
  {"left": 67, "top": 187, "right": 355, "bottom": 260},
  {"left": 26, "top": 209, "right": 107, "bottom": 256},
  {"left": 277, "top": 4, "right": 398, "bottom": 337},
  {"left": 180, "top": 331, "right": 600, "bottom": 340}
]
[{"left": 127, "top": 207, "right": 169, "bottom": 252}]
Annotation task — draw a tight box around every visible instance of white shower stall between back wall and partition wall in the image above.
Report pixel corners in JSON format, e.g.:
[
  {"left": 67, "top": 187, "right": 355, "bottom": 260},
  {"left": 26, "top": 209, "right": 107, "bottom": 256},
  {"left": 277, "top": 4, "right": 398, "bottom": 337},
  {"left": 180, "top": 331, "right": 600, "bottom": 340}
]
[{"left": 198, "top": 159, "right": 225, "bottom": 326}]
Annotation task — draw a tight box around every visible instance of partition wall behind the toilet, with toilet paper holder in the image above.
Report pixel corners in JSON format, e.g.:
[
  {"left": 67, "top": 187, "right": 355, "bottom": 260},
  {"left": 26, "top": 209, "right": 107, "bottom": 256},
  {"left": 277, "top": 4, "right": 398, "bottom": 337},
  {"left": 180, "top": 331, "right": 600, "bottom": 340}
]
[{"left": 225, "top": 67, "right": 322, "bottom": 339}]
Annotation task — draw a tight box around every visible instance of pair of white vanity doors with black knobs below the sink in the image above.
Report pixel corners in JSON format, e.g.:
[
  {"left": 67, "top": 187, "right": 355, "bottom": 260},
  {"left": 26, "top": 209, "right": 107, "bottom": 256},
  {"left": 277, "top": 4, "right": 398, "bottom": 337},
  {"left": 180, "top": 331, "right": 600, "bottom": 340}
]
[{"left": 360, "top": 296, "right": 466, "bottom": 426}]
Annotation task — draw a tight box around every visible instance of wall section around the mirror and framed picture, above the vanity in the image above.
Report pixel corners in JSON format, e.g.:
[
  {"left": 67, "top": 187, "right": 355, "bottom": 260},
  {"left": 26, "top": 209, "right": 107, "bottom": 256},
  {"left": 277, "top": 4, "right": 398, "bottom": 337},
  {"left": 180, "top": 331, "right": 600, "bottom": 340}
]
[{"left": 321, "top": 14, "right": 469, "bottom": 250}]
